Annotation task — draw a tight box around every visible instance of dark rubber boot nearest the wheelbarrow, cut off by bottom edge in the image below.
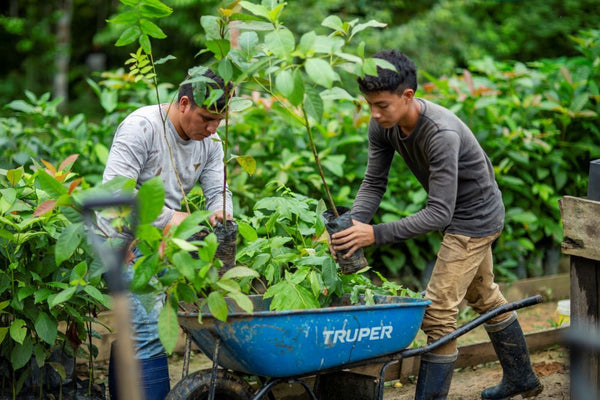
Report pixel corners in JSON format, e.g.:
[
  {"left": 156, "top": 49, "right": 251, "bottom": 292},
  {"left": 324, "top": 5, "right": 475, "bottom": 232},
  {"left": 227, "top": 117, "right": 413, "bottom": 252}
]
[{"left": 415, "top": 351, "right": 458, "bottom": 400}]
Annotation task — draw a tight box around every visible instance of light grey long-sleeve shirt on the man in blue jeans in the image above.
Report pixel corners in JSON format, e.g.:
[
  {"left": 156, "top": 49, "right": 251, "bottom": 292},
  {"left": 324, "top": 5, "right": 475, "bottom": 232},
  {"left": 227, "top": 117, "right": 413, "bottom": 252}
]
[{"left": 99, "top": 105, "right": 233, "bottom": 239}]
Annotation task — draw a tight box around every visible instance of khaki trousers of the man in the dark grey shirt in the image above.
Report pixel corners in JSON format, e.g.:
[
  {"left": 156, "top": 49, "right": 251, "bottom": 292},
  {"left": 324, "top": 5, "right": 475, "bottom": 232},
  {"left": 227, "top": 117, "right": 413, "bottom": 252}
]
[{"left": 421, "top": 232, "right": 511, "bottom": 354}]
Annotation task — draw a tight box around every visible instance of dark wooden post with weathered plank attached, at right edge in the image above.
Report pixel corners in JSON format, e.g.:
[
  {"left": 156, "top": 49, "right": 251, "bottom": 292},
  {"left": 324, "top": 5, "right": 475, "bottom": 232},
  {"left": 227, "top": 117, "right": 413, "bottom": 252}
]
[{"left": 559, "top": 160, "right": 600, "bottom": 399}]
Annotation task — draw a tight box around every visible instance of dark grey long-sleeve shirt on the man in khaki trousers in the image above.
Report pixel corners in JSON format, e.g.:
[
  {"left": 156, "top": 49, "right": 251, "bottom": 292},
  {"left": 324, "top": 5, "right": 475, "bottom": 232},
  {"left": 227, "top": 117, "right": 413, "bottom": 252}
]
[{"left": 352, "top": 99, "right": 504, "bottom": 245}]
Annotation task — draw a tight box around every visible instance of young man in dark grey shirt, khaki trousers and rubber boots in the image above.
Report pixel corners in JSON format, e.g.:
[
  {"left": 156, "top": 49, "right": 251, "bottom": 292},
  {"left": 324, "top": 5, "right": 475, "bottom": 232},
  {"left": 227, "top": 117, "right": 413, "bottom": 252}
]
[{"left": 331, "top": 50, "right": 543, "bottom": 399}]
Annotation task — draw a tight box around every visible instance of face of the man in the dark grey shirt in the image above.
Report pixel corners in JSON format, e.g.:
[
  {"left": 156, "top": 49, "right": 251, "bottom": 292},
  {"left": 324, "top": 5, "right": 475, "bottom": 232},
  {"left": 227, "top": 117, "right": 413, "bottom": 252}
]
[{"left": 365, "top": 89, "right": 411, "bottom": 129}]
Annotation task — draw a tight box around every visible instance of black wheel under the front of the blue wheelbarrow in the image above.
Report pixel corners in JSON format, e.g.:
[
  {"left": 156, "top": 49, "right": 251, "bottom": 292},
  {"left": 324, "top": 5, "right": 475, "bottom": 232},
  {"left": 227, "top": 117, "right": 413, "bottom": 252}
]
[{"left": 166, "top": 370, "right": 253, "bottom": 400}]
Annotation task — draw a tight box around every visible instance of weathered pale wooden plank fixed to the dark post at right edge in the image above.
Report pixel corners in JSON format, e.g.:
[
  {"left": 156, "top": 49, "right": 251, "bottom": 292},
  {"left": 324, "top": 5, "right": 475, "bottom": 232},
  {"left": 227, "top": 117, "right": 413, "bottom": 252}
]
[{"left": 559, "top": 196, "right": 600, "bottom": 261}]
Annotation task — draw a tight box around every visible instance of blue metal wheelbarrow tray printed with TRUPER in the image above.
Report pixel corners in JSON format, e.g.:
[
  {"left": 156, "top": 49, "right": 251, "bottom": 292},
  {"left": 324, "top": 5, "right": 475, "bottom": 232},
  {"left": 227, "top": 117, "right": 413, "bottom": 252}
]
[{"left": 178, "top": 295, "right": 431, "bottom": 378}]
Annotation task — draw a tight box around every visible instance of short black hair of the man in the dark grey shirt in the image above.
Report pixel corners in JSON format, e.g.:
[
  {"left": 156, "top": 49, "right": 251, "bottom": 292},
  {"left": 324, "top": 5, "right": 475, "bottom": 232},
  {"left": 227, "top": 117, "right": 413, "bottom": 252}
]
[{"left": 357, "top": 50, "right": 417, "bottom": 94}]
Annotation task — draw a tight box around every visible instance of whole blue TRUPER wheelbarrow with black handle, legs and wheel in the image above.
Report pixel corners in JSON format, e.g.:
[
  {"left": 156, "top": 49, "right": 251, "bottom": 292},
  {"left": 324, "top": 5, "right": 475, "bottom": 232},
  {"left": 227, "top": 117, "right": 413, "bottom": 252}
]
[{"left": 167, "top": 295, "right": 542, "bottom": 400}]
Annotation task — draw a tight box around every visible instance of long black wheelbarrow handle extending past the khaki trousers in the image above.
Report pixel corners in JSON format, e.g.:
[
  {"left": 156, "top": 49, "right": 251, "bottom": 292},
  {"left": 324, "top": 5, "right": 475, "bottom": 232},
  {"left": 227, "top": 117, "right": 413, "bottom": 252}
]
[{"left": 400, "top": 294, "right": 543, "bottom": 358}]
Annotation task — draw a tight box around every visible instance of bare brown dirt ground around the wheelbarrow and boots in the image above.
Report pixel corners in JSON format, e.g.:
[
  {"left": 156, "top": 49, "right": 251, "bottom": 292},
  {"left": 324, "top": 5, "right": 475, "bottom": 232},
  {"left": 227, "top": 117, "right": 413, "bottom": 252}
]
[{"left": 91, "top": 302, "right": 570, "bottom": 400}]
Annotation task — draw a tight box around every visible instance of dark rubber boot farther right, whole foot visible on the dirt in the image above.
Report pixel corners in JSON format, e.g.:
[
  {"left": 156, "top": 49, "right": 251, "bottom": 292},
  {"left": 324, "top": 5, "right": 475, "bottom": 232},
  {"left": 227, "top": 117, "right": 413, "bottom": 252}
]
[{"left": 481, "top": 313, "right": 544, "bottom": 400}]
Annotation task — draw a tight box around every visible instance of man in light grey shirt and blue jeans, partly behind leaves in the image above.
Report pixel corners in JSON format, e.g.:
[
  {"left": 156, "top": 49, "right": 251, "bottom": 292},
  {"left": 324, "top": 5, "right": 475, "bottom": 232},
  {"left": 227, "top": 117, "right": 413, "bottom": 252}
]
[{"left": 99, "top": 69, "right": 233, "bottom": 400}]
